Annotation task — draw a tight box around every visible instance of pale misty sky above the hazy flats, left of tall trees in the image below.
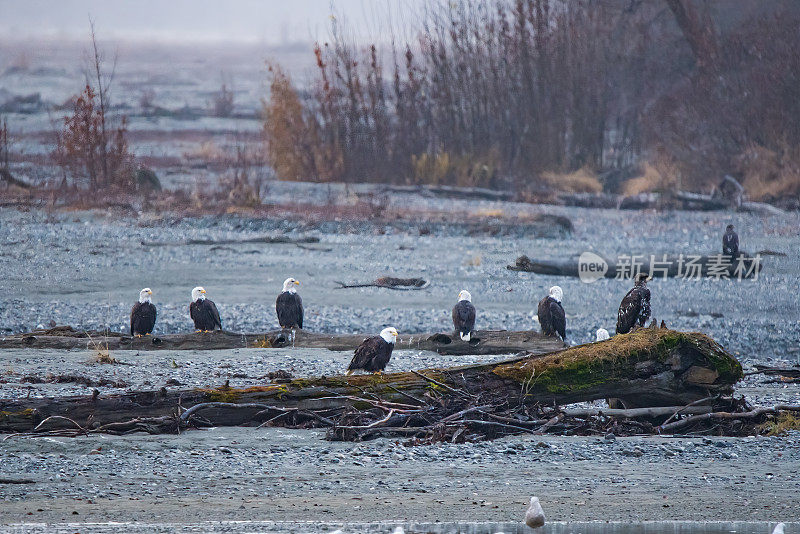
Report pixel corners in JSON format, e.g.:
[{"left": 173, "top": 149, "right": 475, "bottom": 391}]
[{"left": 0, "top": 0, "right": 425, "bottom": 45}]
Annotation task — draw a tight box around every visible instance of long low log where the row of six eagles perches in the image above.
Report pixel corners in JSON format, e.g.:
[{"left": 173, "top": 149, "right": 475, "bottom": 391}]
[{"left": 0, "top": 326, "right": 564, "bottom": 356}]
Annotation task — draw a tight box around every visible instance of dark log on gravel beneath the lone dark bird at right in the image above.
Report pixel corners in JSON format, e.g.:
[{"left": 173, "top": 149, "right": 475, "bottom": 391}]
[{"left": 506, "top": 252, "right": 763, "bottom": 279}]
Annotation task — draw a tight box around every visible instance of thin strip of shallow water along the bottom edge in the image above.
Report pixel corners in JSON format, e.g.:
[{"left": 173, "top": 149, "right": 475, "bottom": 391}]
[{"left": 0, "top": 521, "right": 800, "bottom": 534}]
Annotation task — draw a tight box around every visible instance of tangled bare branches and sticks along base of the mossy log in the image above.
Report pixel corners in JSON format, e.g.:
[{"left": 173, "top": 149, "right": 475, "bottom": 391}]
[{"left": 10, "top": 390, "right": 800, "bottom": 445}]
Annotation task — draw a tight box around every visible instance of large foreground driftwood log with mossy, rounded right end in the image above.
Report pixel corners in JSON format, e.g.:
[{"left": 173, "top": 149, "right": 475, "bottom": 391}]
[{"left": 0, "top": 329, "right": 742, "bottom": 432}]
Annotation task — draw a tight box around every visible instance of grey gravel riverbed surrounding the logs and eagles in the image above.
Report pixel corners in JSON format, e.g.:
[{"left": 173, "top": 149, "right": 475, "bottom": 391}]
[{"left": 0, "top": 189, "right": 800, "bottom": 523}]
